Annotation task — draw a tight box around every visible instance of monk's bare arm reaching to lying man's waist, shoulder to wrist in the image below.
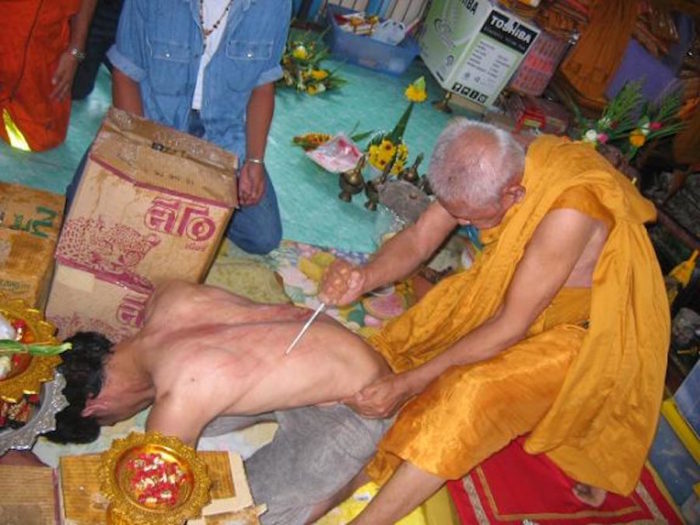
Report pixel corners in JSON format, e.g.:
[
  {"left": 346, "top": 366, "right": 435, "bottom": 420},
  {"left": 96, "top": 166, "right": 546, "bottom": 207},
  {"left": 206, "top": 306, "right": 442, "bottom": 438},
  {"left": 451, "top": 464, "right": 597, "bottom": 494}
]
[{"left": 407, "top": 209, "right": 596, "bottom": 393}]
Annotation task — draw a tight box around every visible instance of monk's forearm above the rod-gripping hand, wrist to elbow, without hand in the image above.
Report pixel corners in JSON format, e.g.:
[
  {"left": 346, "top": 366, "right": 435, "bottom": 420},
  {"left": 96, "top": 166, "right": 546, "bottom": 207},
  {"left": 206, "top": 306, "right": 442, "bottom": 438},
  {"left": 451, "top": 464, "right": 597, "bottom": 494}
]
[{"left": 362, "top": 202, "right": 457, "bottom": 292}]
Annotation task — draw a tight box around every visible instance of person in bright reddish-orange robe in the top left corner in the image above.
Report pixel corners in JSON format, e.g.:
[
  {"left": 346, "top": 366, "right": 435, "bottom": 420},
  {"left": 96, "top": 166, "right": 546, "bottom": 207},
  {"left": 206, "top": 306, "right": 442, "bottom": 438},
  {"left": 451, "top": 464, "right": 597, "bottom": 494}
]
[{"left": 0, "top": 0, "right": 96, "bottom": 151}]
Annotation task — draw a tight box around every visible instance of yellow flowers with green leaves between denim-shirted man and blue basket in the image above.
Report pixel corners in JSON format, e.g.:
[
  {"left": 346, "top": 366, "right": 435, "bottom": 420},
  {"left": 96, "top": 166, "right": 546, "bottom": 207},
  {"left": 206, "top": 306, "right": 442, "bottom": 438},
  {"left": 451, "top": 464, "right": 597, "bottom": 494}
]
[{"left": 280, "top": 32, "right": 345, "bottom": 95}]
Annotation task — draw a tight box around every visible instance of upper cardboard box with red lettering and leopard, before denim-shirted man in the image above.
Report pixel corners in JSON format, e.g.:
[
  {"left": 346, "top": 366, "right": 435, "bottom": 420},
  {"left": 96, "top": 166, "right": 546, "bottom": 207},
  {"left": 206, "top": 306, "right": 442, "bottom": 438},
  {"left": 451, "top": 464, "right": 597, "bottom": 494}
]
[{"left": 56, "top": 109, "right": 238, "bottom": 284}]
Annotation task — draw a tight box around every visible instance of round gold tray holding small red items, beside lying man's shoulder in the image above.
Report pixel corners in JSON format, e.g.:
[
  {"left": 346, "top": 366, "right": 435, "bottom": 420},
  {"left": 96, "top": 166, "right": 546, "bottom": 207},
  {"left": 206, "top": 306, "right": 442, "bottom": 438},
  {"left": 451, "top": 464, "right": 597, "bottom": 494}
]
[{"left": 100, "top": 432, "right": 211, "bottom": 525}]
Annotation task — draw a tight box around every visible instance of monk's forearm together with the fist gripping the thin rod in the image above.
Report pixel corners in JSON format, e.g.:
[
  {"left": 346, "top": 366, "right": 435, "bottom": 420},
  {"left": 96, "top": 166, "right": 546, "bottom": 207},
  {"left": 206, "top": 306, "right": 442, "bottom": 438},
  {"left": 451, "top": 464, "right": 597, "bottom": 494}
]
[{"left": 321, "top": 202, "right": 457, "bottom": 305}]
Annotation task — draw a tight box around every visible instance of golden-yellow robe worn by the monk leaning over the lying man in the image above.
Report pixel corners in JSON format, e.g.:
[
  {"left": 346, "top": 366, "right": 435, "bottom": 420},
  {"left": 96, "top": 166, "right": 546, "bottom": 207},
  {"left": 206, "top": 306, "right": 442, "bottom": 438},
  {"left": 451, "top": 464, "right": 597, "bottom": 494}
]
[{"left": 368, "top": 136, "right": 670, "bottom": 494}]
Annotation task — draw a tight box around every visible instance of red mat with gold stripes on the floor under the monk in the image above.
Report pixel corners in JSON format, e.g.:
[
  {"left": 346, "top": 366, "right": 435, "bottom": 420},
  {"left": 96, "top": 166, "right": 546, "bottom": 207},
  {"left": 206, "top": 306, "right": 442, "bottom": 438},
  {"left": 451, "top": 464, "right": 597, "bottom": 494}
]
[{"left": 447, "top": 439, "right": 683, "bottom": 525}]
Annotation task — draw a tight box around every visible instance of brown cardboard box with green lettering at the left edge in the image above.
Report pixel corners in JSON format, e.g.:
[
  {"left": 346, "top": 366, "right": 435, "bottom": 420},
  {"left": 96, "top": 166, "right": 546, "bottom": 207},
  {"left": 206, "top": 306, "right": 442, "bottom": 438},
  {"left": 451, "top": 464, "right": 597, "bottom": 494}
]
[{"left": 0, "top": 182, "right": 65, "bottom": 309}]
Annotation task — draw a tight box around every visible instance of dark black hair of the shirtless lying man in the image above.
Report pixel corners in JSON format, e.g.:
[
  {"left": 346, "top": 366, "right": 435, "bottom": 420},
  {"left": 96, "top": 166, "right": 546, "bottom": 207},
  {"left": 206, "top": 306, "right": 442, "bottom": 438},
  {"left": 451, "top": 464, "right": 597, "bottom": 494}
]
[{"left": 46, "top": 332, "right": 112, "bottom": 443}]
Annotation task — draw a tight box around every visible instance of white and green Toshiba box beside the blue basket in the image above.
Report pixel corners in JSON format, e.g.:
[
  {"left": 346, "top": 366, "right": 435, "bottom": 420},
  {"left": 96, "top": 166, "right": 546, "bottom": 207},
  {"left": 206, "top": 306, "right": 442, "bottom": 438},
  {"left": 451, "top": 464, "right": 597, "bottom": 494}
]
[{"left": 420, "top": 0, "right": 540, "bottom": 106}]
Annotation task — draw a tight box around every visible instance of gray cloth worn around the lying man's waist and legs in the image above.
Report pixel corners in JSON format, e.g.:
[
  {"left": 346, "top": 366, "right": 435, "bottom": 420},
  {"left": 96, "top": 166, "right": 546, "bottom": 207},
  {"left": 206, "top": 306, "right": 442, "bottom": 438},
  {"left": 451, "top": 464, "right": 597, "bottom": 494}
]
[{"left": 204, "top": 404, "right": 393, "bottom": 525}]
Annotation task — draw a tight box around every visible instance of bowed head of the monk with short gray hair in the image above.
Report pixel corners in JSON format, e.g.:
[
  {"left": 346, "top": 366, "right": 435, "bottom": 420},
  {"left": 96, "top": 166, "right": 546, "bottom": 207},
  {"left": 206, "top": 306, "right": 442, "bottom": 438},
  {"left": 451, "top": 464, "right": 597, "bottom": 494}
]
[{"left": 428, "top": 118, "right": 525, "bottom": 229}]
